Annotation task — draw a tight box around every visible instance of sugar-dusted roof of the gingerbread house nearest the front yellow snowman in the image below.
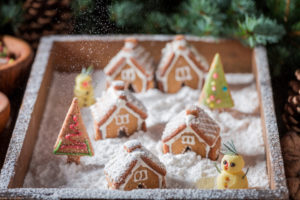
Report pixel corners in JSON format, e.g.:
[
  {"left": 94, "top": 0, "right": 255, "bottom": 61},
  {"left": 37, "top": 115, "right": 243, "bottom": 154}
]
[{"left": 162, "top": 105, "right": 220, "bottom": 146}]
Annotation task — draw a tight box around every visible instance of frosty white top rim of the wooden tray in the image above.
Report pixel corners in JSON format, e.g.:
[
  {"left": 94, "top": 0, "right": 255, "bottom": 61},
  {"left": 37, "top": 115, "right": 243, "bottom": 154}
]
[{"left": 0, "top": 35, "right": 288, "bottom": 199}]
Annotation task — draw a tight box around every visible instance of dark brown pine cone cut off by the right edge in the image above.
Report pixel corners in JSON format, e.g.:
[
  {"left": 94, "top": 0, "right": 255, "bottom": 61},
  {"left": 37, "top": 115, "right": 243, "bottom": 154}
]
[{"left": 282, "top": 69, "right": 300, "bottom": 134}]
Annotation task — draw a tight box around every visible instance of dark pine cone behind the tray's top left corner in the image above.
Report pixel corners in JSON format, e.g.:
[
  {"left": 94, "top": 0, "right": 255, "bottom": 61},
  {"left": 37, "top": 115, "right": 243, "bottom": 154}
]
[{"left": 18, "top": 0, "right": 72, "bottom": 49}]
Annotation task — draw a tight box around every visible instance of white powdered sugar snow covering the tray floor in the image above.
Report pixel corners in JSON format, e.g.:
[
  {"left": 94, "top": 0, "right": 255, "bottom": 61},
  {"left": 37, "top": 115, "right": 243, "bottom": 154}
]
[{"left": 24, "top": 71, "right": 269, "bottom": 189}]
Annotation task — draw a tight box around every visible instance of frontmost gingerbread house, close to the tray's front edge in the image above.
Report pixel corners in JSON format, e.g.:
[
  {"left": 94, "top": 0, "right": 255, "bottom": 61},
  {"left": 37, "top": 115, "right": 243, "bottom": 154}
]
[{"left": 104, "top": 140, "right": 166, "bottom": 190}]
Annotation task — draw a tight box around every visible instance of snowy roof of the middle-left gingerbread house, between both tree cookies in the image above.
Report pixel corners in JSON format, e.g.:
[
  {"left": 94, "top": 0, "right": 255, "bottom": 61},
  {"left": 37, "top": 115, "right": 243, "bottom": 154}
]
[{"left": 90, "top": 81, "right": 147, "bottom": 125}]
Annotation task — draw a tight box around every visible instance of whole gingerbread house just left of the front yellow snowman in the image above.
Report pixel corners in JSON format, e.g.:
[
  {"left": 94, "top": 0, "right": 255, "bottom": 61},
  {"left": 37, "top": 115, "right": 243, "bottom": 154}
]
[{"left": 162, "top": 105, "right": 221, "bottom": 160}]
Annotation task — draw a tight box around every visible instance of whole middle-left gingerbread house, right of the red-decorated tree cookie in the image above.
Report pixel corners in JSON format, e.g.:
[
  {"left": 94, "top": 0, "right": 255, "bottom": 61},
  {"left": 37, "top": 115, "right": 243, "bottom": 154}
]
[{"left": 90, "top": 81, "right": 147, "bottom": 140}]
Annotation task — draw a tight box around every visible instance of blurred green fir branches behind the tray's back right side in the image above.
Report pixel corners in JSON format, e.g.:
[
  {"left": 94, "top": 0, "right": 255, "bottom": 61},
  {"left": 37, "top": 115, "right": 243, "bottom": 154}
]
[{"left": 109, "top": 0, "right": 300, "bottom": 77}]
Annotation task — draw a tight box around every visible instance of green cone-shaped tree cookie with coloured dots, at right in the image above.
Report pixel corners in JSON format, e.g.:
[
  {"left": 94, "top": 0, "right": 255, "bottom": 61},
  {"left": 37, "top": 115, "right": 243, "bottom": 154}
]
[{"left": 199, "top": 53, "right": 234, "bottom": 109}]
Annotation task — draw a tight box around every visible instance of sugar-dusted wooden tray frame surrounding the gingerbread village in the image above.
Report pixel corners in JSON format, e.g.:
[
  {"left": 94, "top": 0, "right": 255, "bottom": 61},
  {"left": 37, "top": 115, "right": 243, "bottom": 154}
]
[{"left": 0, "top": 35, "right": 288, "bottom": 199}]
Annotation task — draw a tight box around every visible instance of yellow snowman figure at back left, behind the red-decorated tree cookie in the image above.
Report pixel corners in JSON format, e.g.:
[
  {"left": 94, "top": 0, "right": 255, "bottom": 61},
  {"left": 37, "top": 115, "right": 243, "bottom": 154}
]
[{"left": 74, "top": 66, "right": 95, "bottom": 108}]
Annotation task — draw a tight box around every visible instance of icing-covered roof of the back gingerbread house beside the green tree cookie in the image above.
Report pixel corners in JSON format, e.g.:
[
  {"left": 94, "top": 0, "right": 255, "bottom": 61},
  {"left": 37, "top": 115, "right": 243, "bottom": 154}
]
[{"left": 157, "top": 35, "right": 209, "bottom": 77}]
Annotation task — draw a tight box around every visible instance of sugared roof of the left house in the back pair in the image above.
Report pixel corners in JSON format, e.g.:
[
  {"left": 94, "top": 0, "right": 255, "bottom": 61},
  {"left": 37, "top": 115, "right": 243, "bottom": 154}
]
[{"left": 104, "top": 38, "right": 154, "bottom": 78}]
